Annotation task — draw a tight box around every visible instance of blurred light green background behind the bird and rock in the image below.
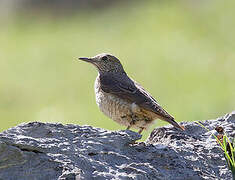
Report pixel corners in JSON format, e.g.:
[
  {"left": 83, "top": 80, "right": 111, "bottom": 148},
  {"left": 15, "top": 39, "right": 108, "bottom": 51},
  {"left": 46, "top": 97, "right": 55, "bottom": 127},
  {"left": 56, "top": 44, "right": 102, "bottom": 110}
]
[{"left": 0, "top": 0, "right": 235, "bottom": 137}]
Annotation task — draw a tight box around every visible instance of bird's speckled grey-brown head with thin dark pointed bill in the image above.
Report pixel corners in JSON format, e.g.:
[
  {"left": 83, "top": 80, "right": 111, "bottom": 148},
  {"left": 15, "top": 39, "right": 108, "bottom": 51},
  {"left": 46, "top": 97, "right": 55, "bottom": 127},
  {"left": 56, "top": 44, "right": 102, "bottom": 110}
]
[{"left": 79, "top": 53, "right": 125, "bottom": 73}]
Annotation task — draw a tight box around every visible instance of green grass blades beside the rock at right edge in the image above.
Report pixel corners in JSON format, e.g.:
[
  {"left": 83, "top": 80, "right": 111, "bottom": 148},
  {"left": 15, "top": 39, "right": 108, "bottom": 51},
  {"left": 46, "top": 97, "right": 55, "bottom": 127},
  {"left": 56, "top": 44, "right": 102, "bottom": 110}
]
[{"left": 196, "top": 122, "right": 235, "bottom": 180}]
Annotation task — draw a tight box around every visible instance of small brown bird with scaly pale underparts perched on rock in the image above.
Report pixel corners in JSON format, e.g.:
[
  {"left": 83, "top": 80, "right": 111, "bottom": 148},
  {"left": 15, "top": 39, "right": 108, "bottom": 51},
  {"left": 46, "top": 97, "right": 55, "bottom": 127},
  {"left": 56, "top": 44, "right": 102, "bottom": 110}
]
[{"left": 79, "top": 53, "right": 184, "bottom": 134}]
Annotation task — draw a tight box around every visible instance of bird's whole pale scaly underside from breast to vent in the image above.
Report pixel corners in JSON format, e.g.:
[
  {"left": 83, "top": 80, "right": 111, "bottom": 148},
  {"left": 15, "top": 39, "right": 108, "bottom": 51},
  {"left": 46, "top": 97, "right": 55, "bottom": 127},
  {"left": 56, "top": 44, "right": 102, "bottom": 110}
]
[{"left": 95, "top": 77, "right": 158, "bottom": 129}]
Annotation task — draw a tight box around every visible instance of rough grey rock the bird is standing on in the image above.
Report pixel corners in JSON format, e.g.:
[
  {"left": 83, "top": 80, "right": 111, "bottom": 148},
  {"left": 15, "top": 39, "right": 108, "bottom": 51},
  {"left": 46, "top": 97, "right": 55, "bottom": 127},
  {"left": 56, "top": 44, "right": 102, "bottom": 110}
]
[{"left": 0, "top": 111, "right": 235, "bottom": 180}]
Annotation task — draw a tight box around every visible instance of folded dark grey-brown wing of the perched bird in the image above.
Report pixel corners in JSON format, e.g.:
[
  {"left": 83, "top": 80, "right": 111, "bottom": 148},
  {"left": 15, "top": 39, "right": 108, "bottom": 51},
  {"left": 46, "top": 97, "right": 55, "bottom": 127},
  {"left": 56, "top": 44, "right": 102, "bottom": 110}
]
[{"left": 100, "top": 74, "right": 174, "bottom": 120}]
